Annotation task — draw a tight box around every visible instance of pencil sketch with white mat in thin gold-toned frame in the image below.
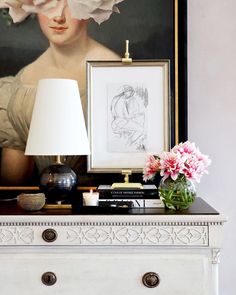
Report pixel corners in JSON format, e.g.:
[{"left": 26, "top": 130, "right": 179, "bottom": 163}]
[{"left": 87, "top": 61, "right": 171, "bottom": 172}]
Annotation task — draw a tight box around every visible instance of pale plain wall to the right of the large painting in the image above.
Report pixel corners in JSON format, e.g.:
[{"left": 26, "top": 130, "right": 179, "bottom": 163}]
[{"left": 188, "top": 0, "right": 236, "bottom": 295}]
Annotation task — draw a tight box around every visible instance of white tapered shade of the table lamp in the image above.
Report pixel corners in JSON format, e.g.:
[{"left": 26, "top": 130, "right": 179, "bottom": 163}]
[{"left": 25, "top": 79, "right": 90, "bottom": 156}]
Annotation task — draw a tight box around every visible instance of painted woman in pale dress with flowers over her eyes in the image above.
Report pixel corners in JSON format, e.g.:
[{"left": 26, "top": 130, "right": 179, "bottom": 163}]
[{"left": 0, "top": 0, "right": 123, "bottom": 185}]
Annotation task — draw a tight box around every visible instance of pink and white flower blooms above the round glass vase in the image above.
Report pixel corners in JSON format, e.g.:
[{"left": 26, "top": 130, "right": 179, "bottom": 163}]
[{"left": 143, "top": 141, "right": 211, "bottom": 182}]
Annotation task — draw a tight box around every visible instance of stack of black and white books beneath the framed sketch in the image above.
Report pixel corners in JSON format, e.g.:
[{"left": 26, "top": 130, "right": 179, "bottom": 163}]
[{"left": 97, "top": 184, "right": 164, "bottom": 208}]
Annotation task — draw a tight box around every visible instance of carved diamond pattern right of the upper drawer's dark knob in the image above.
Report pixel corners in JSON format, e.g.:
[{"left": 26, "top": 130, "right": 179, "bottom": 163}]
[{"left": 66, "top": 226, "right": 208, "bottom": 246}]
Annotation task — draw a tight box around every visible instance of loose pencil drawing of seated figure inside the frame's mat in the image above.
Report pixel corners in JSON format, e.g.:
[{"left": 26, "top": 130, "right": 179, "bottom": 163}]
[{"left": 110, "top": 85, "right": 148, "bottom": 151}]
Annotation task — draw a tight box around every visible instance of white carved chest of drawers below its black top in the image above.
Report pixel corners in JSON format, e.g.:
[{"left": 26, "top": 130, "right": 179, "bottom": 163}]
[{"left": 0, "top": 199, "right": 225, "bottom": 295}]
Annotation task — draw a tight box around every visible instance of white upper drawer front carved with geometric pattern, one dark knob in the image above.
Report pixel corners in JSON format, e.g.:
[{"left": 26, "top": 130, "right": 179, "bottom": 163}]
[{"left": 0, "top": 224, "right": 209, "bottom": 247}]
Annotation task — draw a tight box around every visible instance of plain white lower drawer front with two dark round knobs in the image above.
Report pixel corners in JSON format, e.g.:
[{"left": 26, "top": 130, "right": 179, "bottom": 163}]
[{"left": 0, "top": 249, "right": 211, "bottom": 295}]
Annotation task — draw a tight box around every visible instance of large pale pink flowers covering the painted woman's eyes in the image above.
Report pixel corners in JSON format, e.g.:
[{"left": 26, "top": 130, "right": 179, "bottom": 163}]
[{"left": 0, "top": 0, "right": 124, "bottom": 24}]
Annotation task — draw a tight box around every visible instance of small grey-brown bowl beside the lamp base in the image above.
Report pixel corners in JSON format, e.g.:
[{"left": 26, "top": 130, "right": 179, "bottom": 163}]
[{"left": 17, "top": 193, "right": 45, "bottom": 211}]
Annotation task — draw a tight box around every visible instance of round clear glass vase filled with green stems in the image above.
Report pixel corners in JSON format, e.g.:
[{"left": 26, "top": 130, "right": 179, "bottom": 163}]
[{"left": 158, "top": 175, "right": 196, "bottom": 210}]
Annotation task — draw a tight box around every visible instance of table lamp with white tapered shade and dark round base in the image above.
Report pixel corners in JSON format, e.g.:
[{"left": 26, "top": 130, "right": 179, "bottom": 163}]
[{"left": 25, "top": 79, "right": 90, "bottom": 203}]
